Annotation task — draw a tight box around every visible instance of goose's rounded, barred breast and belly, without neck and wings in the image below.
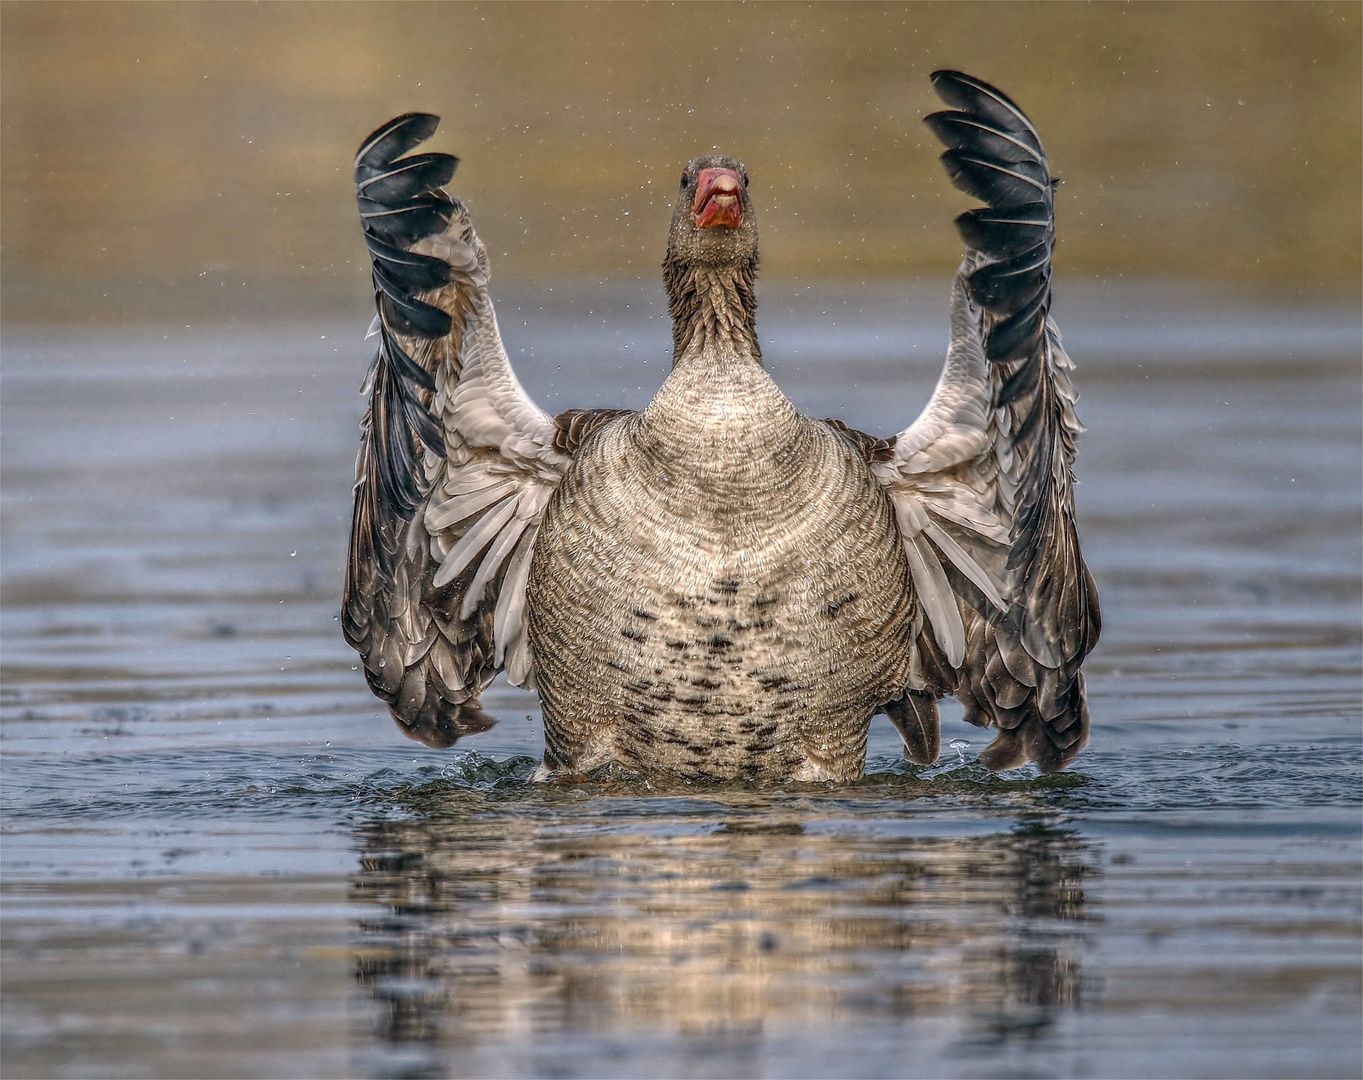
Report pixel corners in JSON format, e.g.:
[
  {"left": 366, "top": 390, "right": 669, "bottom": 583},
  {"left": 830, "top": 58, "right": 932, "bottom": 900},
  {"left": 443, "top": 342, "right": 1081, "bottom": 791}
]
[{"left": 529, "top": 309, "right": 913, "bottom": 780}]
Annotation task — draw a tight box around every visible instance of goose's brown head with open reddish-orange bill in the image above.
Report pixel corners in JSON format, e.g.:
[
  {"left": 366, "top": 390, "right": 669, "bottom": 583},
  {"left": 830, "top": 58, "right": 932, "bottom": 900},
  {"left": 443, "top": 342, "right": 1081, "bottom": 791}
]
[{"left": 667, "top": 154, "right": 758, "bottom": 269}]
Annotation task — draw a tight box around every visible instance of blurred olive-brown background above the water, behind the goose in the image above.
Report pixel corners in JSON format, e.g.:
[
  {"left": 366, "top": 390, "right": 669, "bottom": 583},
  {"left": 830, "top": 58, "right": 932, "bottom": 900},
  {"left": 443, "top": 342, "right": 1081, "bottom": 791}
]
[{"left": 0, "top": 3, "right": 1363, "bottom": 320}]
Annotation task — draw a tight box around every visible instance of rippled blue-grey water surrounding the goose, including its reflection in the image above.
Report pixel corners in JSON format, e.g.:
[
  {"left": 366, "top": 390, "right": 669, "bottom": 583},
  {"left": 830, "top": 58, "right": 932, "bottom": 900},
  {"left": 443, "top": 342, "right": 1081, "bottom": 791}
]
[{"left": 0, "top": 288, "right": 1363, "bottom": 1077}]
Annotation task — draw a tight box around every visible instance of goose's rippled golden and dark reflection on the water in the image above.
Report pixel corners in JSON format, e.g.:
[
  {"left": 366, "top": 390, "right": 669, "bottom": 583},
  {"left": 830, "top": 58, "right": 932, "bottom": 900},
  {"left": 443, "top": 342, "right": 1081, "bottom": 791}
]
[{"left": 354, "top": 800, "right": 1094, "bottom": 1075}]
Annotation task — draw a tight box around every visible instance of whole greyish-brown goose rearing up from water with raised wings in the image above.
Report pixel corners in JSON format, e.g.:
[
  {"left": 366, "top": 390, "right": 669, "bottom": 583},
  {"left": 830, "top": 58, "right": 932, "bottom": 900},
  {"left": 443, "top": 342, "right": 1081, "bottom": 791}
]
[{"left": 342, "top": 71, "right": 1100, "bottom": 781}]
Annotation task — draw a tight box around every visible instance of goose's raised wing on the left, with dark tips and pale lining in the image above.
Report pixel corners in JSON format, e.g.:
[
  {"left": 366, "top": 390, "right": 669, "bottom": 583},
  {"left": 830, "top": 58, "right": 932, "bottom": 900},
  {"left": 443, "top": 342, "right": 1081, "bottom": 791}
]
[{"left": 342, "top": 113, "right": 571, "bottom": 746}]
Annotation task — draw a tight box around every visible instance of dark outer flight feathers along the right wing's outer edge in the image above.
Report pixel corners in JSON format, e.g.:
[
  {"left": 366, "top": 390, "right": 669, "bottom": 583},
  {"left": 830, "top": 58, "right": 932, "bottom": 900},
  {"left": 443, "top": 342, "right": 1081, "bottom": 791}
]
[{"left": 925, "top": 71, "right": 1100, "bottom": 772}]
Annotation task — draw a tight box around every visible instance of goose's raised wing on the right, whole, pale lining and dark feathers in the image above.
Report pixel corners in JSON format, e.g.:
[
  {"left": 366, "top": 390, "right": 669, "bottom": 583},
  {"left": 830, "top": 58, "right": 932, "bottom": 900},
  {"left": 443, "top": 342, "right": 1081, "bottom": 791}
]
[{"left": 876, "top": 71, "right": 1100, "bottom": 772}]
